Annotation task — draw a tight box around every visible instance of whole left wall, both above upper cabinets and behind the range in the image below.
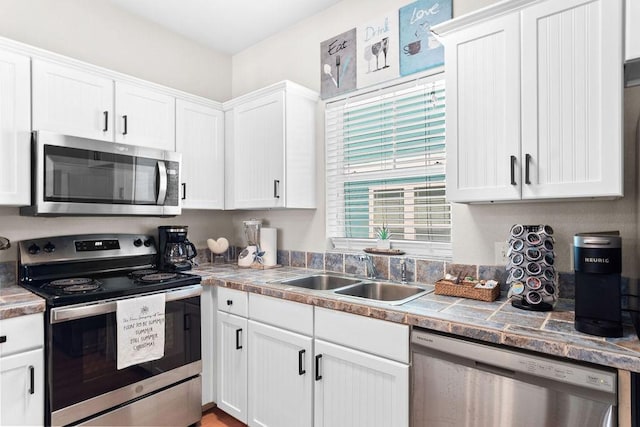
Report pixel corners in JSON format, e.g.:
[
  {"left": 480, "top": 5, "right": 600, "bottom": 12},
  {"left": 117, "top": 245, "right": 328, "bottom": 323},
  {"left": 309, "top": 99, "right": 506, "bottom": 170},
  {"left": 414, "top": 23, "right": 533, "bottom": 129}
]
[{"left": 0, "top": 0, "right": 239, "bottom": 261}]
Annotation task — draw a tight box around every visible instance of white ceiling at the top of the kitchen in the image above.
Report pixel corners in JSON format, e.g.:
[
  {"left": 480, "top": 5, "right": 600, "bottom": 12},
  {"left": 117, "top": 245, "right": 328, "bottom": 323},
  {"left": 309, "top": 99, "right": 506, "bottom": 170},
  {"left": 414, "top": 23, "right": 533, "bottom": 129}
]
[{"left": 109, "top": 0, "right": 340, "bottom": 55}]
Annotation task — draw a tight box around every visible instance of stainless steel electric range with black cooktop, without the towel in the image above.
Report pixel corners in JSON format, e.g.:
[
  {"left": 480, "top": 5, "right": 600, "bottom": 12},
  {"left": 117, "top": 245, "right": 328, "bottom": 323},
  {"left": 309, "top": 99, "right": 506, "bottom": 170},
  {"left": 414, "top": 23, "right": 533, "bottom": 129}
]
[{"left": 19, "top": 234, "right": 202, "bottom": 426}]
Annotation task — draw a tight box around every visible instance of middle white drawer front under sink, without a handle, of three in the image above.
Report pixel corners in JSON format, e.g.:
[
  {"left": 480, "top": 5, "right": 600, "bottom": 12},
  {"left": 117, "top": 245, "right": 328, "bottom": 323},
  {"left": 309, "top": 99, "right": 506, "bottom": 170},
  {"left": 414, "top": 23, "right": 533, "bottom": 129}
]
[{"left": 249, "top": 294, "right": 313, "bottom": 336}]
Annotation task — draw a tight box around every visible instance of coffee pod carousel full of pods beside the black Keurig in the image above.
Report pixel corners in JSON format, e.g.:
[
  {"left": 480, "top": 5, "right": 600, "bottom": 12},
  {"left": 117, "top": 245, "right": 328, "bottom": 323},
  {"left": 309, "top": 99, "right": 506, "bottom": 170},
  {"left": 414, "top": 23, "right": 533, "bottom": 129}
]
[{"left": 507, "top": 224, "right": 559, "bottom": 311}]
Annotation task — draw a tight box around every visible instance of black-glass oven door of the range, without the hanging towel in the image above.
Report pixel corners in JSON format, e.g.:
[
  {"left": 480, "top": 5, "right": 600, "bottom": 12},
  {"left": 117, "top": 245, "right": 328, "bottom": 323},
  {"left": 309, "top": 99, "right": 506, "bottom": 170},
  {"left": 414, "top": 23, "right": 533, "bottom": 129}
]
[{"left": 46, "top": 285, "right": 202, "bottom": 425}]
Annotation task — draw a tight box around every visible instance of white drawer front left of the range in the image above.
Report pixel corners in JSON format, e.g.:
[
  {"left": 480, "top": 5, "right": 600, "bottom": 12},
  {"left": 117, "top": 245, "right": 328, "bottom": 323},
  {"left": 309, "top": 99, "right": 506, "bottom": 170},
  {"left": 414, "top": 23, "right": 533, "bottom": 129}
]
[{"left": 0, "top": 313, "right": 44, "bottom": 357}]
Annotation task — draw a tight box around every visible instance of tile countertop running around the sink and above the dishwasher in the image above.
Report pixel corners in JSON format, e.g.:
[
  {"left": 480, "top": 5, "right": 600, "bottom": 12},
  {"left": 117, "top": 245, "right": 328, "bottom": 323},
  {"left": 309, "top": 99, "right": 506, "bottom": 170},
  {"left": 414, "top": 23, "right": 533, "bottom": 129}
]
[{"left": 193, "top": 264, "right": 640, "bottom": 372}]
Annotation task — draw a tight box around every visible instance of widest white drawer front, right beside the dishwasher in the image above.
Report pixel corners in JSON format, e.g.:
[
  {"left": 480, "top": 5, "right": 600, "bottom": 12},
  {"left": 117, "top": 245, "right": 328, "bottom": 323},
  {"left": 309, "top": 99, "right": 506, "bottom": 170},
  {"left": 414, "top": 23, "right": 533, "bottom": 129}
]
[{"left": 315, "top": 307, "right": 409, "bottom": 363}]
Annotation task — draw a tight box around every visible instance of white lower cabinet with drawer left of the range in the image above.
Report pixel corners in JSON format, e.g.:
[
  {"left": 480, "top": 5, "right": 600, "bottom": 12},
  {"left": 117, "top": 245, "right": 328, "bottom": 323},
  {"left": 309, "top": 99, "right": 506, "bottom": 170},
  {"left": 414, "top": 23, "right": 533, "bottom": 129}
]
[{"left": 0, "top": 313, "right": 44, "bottom": 426}]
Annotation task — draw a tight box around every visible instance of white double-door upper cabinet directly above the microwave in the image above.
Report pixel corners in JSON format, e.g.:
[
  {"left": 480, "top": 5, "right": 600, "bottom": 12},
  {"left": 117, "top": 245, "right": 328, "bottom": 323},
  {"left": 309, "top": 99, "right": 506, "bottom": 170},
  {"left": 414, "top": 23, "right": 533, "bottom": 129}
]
[{"left": 32, "top": 59, "right": 175, "bottom": 151}]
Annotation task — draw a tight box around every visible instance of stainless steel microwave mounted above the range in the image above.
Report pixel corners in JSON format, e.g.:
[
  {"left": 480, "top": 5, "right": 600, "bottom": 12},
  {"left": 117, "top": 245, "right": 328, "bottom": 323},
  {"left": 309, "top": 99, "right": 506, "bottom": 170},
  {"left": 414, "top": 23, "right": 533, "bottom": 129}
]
[{"left": 20, "top": 131, "right": 182, "bottom": 216}]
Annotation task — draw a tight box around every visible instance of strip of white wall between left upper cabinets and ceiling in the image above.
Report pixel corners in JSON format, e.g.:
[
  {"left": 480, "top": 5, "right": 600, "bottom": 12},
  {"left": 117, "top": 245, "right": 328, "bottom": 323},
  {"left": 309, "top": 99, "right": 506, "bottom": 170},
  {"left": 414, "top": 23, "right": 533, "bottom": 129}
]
[{"left": 0, "top": 0, "right": 231, "bottom": 101}]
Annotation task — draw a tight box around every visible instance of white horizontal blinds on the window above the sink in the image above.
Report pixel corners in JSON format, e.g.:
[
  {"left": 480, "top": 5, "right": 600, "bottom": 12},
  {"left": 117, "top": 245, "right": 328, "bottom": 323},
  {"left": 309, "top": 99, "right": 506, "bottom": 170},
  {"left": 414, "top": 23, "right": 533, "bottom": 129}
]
[{"left": 325, "top": 75, "right": 451, "bottom": 258}]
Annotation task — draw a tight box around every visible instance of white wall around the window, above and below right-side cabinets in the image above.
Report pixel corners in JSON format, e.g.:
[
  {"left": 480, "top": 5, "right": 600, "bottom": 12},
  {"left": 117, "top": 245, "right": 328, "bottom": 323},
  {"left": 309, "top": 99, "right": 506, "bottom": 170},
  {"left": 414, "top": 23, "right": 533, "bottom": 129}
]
[{"left": 233, "top": 0, "right": 640, "bottom": 277}]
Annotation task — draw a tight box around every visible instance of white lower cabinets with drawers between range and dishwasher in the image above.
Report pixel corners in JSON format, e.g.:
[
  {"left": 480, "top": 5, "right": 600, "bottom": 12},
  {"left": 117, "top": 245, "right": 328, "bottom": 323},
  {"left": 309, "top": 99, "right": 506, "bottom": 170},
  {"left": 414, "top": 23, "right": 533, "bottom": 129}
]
[{"left": 217, "top": 288, "right": 409, "bottom": 427}]
